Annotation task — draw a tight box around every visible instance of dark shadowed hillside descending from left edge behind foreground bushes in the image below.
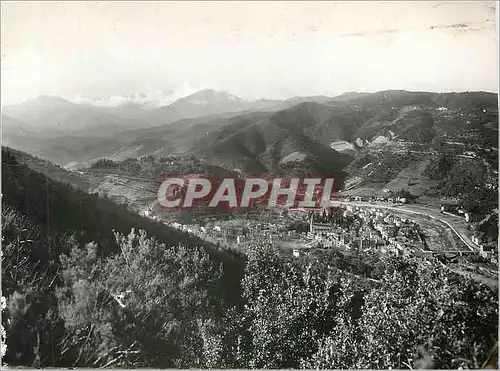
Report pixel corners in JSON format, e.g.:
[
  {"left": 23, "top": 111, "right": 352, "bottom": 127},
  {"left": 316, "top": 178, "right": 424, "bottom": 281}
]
[{"left": 2, "top": 149, "right": 243, "bottom": 367}]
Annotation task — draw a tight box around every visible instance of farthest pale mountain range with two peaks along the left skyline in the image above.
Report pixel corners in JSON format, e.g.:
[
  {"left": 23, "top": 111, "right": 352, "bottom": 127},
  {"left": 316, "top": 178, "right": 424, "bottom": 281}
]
[{"left": 2, "top": 89, "right": 350, "bottom": 137}]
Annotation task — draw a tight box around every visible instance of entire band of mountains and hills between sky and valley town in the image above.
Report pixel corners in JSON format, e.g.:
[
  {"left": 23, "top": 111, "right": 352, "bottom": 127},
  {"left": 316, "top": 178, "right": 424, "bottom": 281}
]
[{"left": 2, "top": 90, "right": 498, "bottom": 183}]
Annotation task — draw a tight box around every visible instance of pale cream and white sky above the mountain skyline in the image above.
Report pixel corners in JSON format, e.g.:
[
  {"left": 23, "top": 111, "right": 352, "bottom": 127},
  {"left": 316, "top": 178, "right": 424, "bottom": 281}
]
[{"left": 1, "top": 0, "right": 498, "bottom": 105}]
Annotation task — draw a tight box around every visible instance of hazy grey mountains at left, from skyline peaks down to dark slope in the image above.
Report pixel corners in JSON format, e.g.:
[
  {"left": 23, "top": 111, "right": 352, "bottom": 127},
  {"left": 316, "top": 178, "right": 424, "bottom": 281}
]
[{"left": 2, "top": 89, "right": 336, "bottom": 164}]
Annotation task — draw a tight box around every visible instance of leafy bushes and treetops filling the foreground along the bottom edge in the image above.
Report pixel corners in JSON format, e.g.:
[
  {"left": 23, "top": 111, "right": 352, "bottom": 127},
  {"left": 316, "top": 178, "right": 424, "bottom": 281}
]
[{"left": 2, "top": 211, "right": 498, "bottom": 369}]
